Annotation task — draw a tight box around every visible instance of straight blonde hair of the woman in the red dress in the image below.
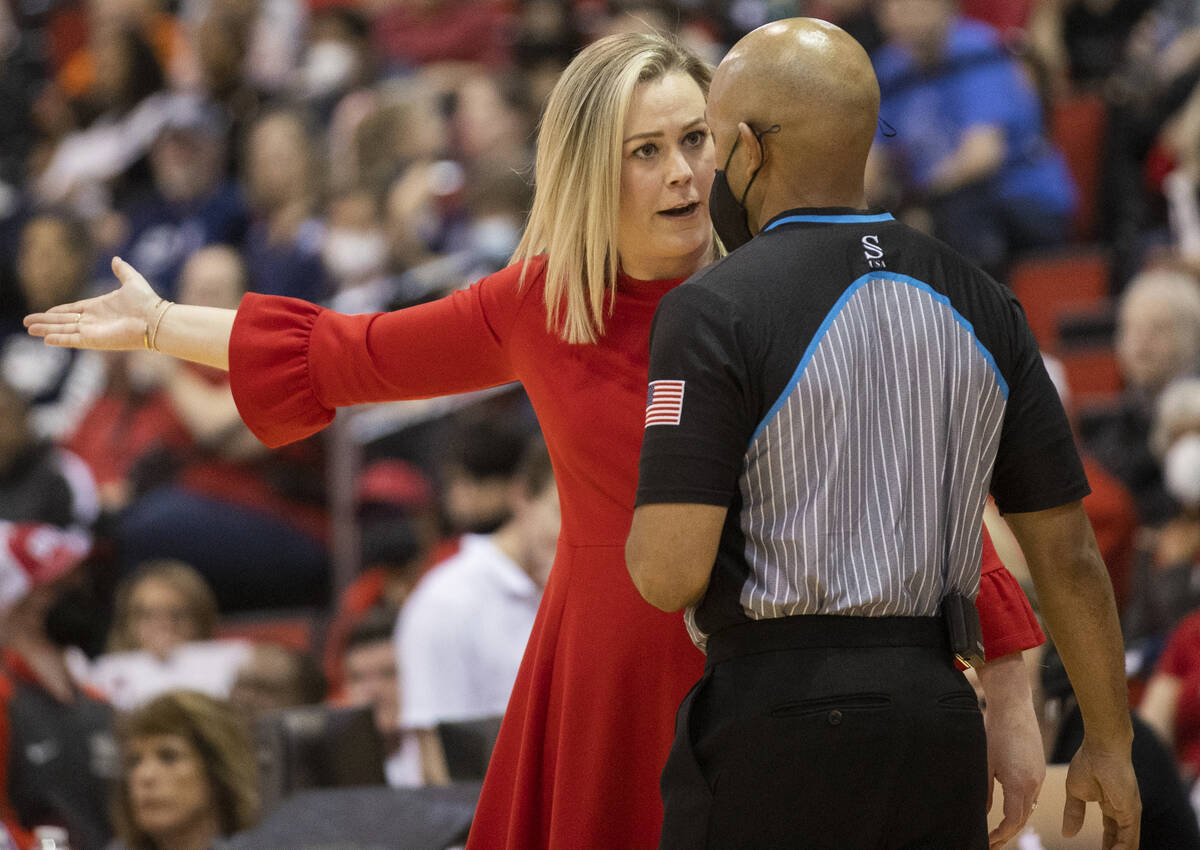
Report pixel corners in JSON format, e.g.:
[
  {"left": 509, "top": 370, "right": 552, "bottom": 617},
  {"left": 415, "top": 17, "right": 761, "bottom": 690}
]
[{"left": 512, "top": 32, "right": 712, "bottom": 342}]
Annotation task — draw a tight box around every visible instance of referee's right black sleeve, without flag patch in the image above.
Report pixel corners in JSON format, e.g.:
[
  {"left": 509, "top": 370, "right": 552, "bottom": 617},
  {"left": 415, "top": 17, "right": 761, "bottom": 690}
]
[{"left": 991, "top": 298, "right": 1091, "bottom": 514}]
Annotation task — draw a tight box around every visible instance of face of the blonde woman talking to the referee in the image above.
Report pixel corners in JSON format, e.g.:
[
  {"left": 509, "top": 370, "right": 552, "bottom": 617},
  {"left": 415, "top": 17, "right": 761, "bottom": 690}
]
[{"left": 617, "top": 73, "right": 716, "bottom": 280}]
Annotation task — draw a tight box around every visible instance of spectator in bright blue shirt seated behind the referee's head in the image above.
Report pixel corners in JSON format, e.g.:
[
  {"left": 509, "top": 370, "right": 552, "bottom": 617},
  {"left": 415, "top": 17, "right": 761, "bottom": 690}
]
[{"left": 868, "top": 0, "right": 1075, "bottom": 279}]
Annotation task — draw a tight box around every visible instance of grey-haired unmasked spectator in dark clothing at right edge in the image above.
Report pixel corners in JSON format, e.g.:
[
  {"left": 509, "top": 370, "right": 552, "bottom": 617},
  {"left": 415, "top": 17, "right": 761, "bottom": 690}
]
[{"left": 1081, "top": 269, "right": 1200, "bottom": 526}]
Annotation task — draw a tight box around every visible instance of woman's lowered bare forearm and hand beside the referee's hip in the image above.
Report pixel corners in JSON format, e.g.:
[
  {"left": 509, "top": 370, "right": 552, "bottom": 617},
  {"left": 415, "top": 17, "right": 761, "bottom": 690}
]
[{"left": 977, "top": 652, "right": 1046, "bottom": 848}]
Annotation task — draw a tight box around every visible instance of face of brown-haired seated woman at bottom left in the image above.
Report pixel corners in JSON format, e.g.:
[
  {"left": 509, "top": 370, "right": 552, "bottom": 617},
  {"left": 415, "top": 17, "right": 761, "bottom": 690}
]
[{"left": 125, "top": 735, "right": 216, "bottom": 846}]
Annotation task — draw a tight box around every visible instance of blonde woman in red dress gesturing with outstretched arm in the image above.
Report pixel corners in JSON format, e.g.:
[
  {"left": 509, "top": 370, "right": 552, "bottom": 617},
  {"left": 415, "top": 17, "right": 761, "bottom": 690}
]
[{"left": 26, "top": 35, "right": 1040, "bottom": 850}]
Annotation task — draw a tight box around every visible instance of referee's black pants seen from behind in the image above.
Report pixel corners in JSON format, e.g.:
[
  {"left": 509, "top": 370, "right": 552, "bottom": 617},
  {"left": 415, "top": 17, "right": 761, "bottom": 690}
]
[{"left": 659, "top": 616, "right": 988, "bottom": 850}]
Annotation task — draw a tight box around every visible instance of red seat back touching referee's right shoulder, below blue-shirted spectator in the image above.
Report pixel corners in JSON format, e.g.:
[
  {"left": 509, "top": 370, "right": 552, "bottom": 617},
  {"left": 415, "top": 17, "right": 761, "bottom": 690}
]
[{"left": 1009, "top": 249, "right": 1109, "bottom": 353}]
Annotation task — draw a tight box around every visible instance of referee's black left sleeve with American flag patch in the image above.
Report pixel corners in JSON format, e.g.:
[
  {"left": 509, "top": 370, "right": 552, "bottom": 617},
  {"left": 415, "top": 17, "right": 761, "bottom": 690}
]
[{"left": 637, "top": 285, "right": 754, "bottom": 507}]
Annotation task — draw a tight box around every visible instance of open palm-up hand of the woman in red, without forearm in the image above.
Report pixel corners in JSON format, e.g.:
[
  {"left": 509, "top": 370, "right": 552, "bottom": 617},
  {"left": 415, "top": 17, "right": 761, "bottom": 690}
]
[{"left": 25, "top": 257, "right": 162, "bottom": 351}]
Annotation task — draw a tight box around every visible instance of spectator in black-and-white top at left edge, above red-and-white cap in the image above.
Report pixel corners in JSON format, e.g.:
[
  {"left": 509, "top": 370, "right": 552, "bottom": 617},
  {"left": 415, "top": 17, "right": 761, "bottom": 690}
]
[{"left": 0, "top": 381, "right": 100, "bottom": 528}]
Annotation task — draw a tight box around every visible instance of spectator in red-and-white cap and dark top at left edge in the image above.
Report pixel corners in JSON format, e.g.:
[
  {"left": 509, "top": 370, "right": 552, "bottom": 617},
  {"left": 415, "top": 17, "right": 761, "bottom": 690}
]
[{"left": 0, "top": 537, "right": 118, "bottom": 850}]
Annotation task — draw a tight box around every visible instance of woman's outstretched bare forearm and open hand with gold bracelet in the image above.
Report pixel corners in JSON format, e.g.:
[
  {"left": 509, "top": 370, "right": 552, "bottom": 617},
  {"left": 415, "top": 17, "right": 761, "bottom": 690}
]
[{"left": 25, "top": 257, "right": 238, "bottom": 370}]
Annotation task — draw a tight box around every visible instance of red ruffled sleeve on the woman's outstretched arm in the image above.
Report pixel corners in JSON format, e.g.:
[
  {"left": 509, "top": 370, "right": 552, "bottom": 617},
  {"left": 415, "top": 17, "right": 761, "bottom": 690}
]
[{"left": 229, "top": 265, "right": 532, "bottom": 448}]
